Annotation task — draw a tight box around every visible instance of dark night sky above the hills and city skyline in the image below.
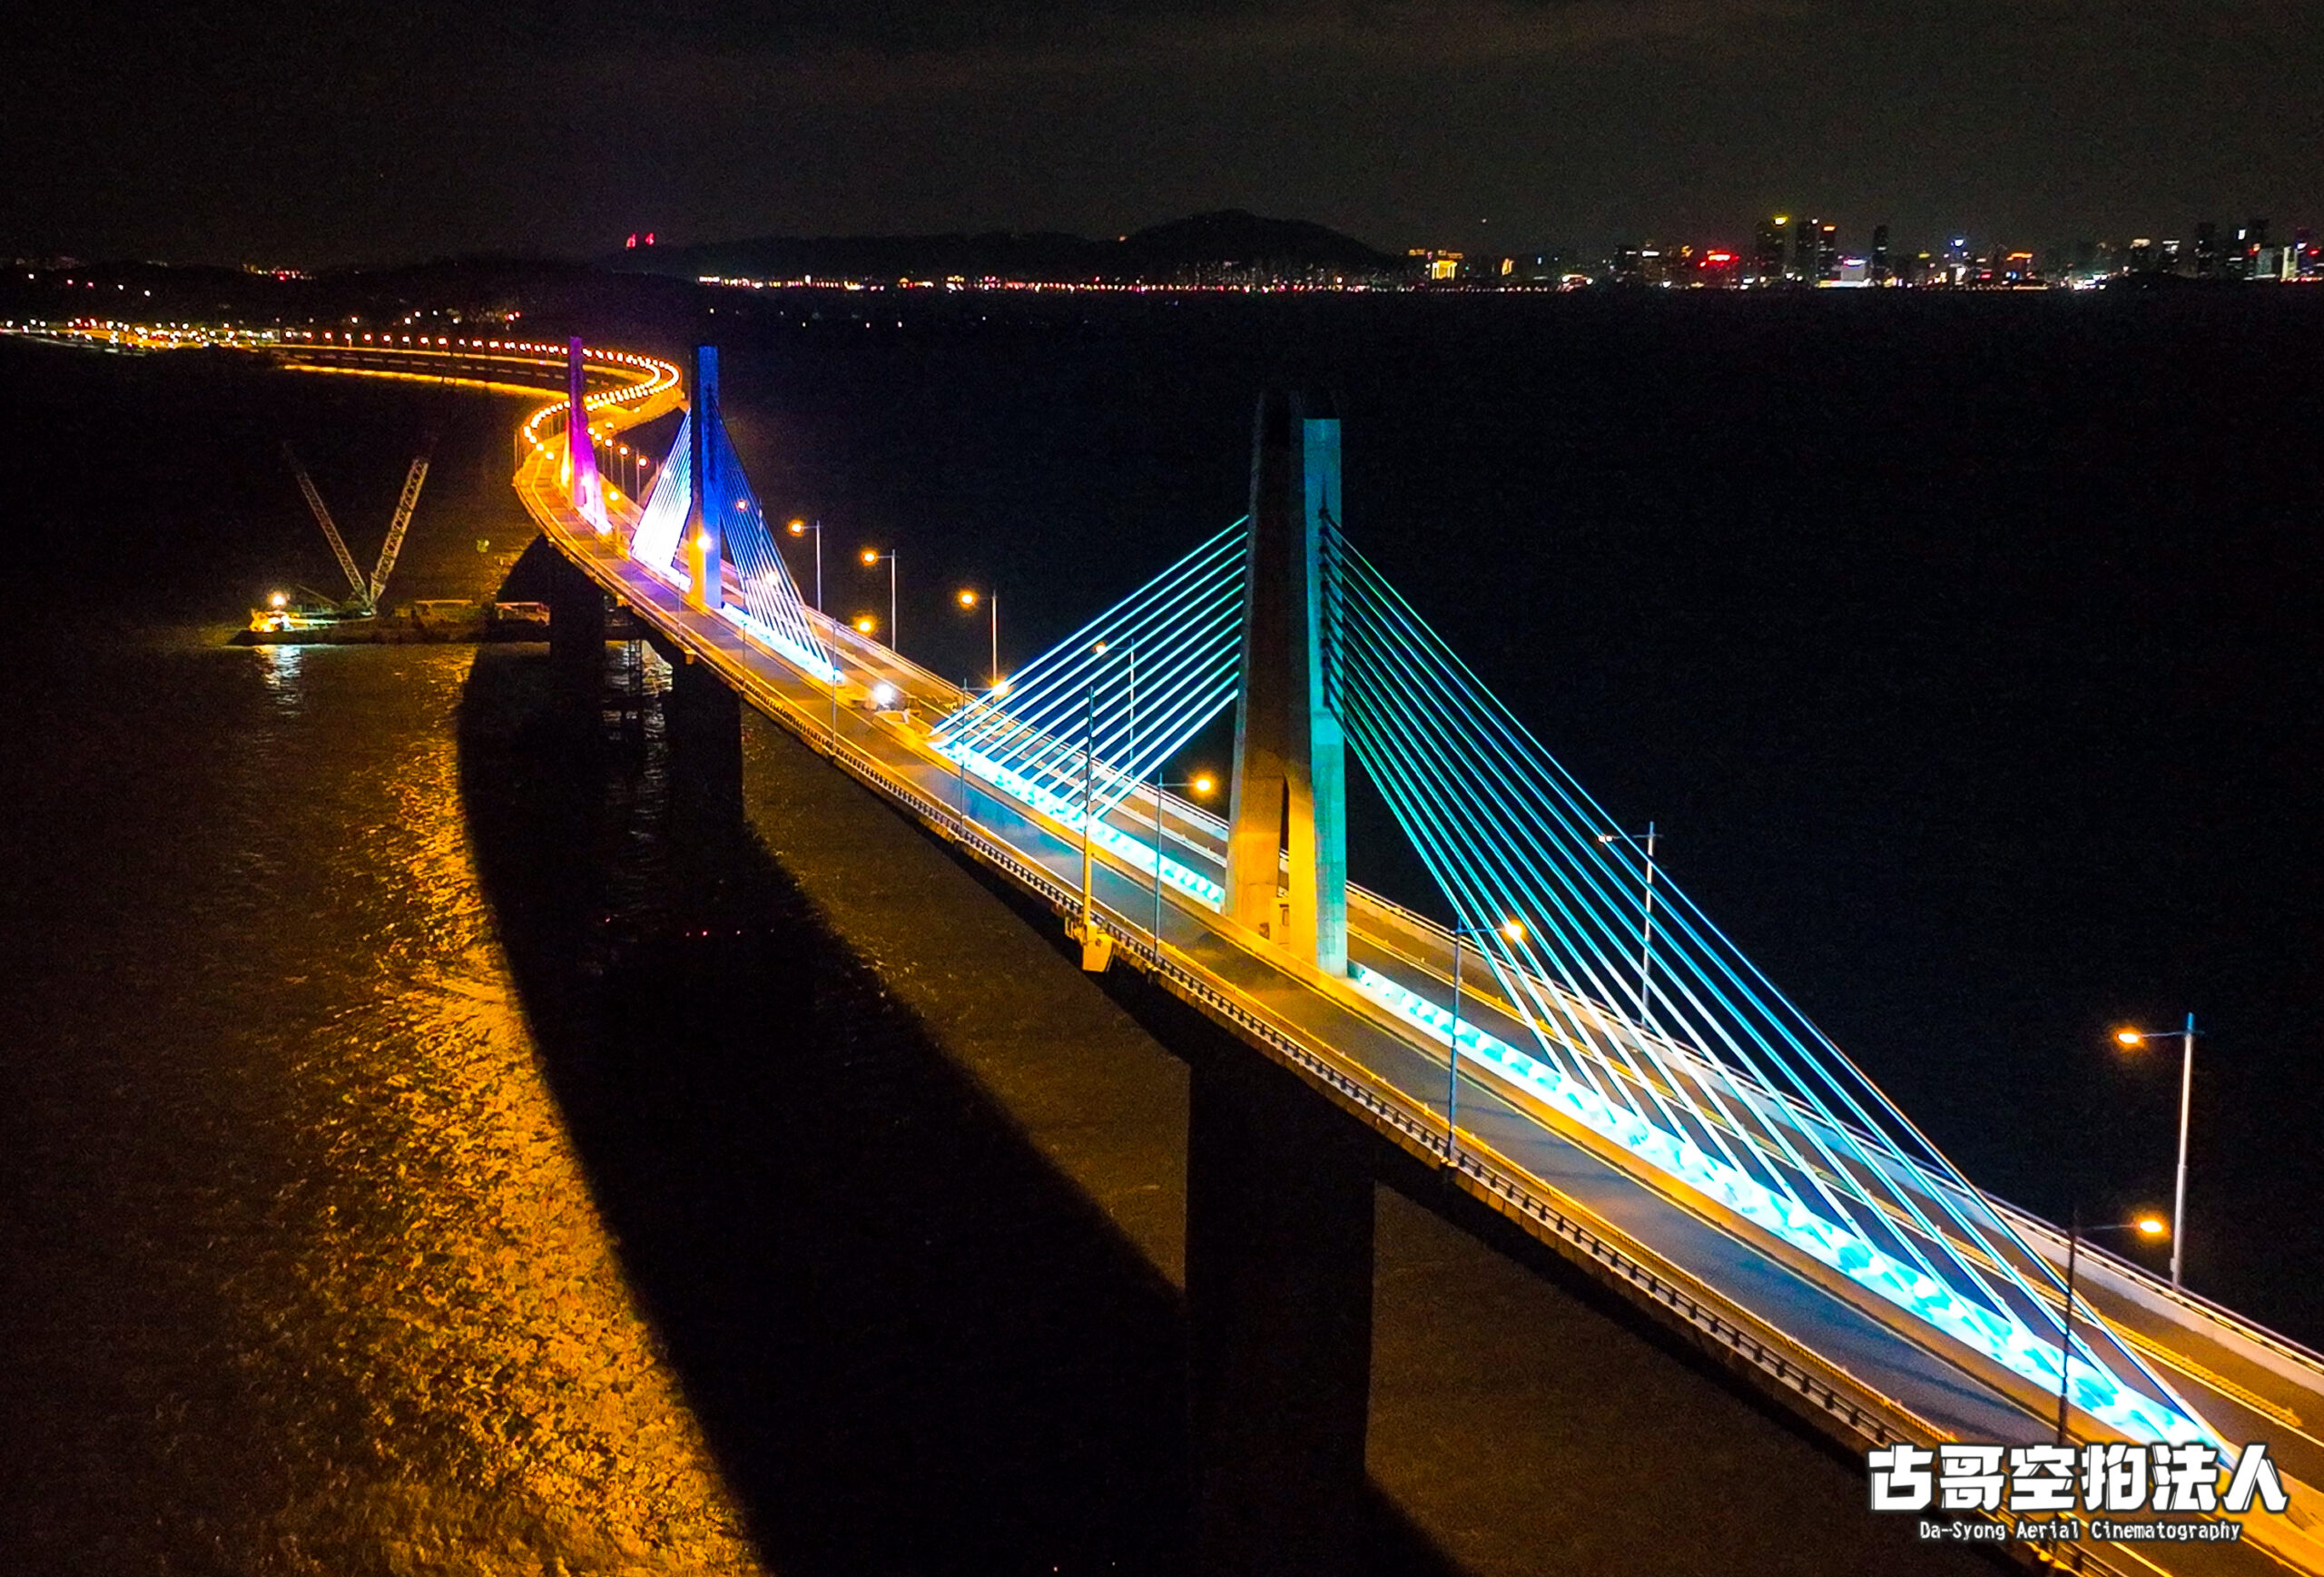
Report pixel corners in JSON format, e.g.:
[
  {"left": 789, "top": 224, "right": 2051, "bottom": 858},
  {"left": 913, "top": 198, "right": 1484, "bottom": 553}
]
[{"left": 18, "top": 0, "right": 2324, "bottom": 265}]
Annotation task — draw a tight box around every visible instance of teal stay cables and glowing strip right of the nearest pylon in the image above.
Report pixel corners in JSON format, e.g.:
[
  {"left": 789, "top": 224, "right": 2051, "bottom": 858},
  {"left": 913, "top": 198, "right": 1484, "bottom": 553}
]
[{"left": 1336, "top": 544, "right": 2211, "bottom": 1440}]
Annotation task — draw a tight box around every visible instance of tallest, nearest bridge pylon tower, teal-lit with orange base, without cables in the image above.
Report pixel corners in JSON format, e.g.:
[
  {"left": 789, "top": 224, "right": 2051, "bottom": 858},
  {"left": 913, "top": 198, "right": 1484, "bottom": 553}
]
[{"left": 1227, "top": 395, "right": 1348, "bottom": 975}]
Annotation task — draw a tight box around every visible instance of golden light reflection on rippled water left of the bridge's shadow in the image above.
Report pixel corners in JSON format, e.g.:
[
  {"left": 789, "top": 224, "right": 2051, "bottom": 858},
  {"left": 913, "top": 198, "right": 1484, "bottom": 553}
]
[{"left": 0, "top": 646, "right": 758, "bottom": 1574}]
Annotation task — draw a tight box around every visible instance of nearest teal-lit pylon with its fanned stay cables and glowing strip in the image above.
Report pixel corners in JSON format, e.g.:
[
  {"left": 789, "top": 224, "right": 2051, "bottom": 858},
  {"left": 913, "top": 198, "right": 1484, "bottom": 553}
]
[{"left": 915, "top": 397, "right": 2208, "bottom": 1467}]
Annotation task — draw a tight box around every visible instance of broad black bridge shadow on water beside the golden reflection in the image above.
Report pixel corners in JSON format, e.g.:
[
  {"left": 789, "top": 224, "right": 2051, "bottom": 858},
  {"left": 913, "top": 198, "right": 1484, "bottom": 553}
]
[{"left": 460, "top": 646, "right": 1448, "bottom": 1577}]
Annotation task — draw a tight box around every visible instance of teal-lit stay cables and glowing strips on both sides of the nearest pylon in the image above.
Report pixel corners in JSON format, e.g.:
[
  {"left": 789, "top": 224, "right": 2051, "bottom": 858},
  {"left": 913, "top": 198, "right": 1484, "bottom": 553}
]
[{"left": 971, "top": 510, "right": 2215, "bottom": 1443}]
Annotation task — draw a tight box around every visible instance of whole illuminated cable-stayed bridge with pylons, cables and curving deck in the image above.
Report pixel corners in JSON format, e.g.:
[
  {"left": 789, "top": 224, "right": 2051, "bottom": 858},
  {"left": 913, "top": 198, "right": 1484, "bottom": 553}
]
[{"left": 32, "top": 320, "right": 2324, "bottom": 1572}]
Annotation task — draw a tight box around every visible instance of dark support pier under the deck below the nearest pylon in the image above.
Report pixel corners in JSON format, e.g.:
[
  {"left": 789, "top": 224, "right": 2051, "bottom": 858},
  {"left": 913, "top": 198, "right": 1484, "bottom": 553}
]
[{"left": 1186, "top": 1060, "right": 1374, "bottom": 1577}]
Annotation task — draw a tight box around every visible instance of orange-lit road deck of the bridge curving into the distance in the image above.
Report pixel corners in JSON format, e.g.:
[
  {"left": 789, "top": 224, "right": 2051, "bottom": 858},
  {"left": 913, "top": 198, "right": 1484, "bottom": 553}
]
[{"left": 190, "top": 331, "right": 2324, "bottom": 1572}]
